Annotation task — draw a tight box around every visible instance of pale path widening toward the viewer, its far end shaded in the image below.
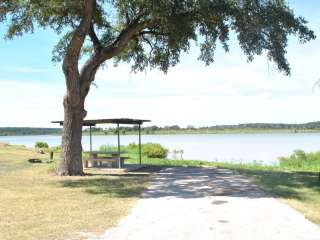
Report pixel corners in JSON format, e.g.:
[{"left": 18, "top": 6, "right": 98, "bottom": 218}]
[{"left": 92, "top": 168, "right": 320, "bottom": 240}]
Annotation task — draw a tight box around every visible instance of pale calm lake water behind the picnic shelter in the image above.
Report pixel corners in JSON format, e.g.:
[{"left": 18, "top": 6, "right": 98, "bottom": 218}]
[{"left": 0, "top": 133, "right": 320, "bottom": 164}]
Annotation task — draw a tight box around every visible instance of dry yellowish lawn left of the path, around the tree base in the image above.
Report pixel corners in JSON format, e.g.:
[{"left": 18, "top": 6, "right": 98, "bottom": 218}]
[{"left": 0, "top": 146, "right": 148, "bottom": 240}]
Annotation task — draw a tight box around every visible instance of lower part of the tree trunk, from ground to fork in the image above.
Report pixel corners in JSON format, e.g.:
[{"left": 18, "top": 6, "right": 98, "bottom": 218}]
[{"left": 58, "top": 94, "right": 85, "bottom": 176}]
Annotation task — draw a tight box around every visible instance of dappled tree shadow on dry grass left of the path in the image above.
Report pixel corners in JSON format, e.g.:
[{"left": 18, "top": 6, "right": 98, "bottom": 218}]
[{"left": 59, "top": 174, "right": 148, "bottom": 198}]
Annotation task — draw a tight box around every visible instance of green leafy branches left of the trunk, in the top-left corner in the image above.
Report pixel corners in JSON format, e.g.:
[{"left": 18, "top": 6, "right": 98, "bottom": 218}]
[{"left": 0, "top": 0, "right": 83, "bottom": 39}]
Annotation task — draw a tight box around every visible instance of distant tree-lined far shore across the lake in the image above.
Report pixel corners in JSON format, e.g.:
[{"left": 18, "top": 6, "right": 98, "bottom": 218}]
[{"left": 0, "top": 121, "right": 320, "bottom": 136}]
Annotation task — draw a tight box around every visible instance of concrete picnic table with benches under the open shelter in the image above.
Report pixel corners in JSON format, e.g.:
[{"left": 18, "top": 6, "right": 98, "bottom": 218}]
[{"left": 84, "top": 151, "right": 126, "bottom": 168}]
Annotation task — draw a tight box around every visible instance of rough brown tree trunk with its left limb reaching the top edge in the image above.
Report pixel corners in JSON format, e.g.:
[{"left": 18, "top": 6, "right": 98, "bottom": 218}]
[{"left": 58, "top": 0, "right": 96, "bottom": 176}]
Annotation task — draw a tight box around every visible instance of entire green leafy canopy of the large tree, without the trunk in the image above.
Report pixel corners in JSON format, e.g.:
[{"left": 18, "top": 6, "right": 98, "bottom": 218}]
[{"left": 0, "top": 0, "right": 315, "bottom": 74}]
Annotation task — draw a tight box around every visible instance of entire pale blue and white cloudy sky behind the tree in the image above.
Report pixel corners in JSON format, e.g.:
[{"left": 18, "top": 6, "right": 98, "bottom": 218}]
[{"left": 0, "top": 0, "right": 320, "bottom": 127}]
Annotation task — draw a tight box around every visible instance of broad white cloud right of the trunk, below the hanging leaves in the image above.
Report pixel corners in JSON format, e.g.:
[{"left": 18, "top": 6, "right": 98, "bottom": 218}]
[{"left": 81, "top": 35, "right": 320, "bottom": 126}]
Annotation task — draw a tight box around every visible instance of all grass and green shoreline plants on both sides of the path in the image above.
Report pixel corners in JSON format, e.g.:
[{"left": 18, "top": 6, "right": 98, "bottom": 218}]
[{"left": 0, "top": 143, "right": 320, "bottom": 240}]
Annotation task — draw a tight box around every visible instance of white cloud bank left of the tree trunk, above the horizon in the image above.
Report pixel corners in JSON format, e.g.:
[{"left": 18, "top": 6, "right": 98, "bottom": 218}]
[{"left": 0, "top": 80, "right": 64, "bottom": 127}]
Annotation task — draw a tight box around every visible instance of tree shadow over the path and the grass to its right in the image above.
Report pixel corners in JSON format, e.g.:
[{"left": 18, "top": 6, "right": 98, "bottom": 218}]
[{"left": 138, "top": 167, "right": 320, "bottom": 199}]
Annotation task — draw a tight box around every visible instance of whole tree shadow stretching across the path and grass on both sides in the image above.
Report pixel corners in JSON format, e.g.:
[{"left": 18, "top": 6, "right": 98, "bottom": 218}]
[{"left": 60, "top": 165, "right": 320, "bottom": 200}]
